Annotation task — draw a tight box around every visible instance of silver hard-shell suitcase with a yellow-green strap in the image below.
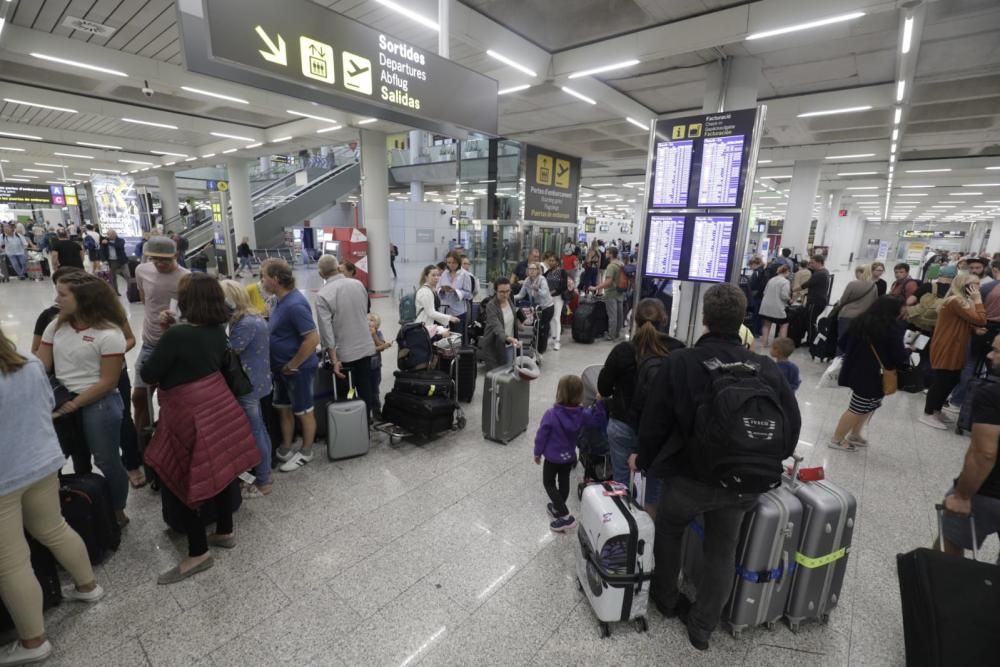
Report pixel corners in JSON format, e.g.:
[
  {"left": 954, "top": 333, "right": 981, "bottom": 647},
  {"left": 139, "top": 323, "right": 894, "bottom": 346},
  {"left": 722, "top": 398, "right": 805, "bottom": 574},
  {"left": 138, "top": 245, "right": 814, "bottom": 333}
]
[{"left": 785, "top": 477, "right": 858, "bottom": 632}]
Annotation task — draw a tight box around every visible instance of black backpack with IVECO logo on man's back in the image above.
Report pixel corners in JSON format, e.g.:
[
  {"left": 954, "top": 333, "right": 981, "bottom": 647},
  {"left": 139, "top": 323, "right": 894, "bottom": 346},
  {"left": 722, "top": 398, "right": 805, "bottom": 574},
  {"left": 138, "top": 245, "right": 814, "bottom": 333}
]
[{"left": 688, "top": 359, "right": 790, "bottom": 493}]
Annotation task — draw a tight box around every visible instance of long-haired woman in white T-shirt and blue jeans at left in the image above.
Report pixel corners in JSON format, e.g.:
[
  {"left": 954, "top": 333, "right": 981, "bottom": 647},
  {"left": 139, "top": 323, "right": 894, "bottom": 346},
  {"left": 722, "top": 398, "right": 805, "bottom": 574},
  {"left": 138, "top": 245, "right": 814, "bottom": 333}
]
[{"left": 38, "top": 272, "right": 128, "bottom": 526}]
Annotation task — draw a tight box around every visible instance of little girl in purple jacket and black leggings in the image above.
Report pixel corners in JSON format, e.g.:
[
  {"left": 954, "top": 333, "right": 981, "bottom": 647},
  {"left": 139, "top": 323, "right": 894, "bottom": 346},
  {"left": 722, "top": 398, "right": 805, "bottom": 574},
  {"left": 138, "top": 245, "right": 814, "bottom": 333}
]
[{"left": 535, "top": 375, "right": 607, "bottom": 533}]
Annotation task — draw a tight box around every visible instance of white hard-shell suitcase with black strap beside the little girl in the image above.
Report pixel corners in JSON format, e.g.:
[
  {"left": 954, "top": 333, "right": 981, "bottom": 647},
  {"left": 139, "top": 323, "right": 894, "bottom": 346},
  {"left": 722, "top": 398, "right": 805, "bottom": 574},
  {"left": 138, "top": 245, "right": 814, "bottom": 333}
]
[{"left": 576, "top": 482, "right": 654, "bottom": 637}]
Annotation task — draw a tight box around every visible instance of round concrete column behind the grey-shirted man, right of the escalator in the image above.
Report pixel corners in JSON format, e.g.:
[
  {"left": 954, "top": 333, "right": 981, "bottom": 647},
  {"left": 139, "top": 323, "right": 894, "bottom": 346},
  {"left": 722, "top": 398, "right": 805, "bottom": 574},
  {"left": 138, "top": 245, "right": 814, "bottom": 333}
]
[{"left": 361, "top": 129, "right": 392, "bottom": 292}]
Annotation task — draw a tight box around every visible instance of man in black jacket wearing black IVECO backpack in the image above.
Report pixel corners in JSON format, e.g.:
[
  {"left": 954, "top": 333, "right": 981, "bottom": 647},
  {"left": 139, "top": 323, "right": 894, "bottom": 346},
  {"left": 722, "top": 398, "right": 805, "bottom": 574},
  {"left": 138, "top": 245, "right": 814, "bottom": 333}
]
[{"left": 635, "top": 283, "right": 802, "bottom": 650}]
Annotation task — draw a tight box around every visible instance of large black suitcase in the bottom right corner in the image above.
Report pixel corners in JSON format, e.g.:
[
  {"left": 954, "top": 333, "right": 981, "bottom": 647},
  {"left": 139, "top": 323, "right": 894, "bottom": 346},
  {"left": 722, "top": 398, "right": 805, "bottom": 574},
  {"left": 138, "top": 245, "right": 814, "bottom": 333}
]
[{"left": 896, "top": 505, "right": 1000, "bottom": 667}]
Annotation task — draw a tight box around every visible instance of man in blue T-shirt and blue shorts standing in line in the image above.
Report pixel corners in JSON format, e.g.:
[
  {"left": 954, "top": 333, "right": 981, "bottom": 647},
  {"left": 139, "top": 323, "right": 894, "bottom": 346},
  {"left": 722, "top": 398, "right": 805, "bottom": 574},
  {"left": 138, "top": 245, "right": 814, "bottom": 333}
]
[{"left": 260, "top": 259, "right": 319, "bottom": 472}]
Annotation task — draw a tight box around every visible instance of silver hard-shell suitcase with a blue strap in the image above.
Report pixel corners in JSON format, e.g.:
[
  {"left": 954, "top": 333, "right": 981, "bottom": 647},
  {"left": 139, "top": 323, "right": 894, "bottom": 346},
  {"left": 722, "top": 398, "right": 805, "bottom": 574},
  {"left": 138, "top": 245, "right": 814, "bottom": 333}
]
[{"left": 722, "top": 486, "right": 802, "bottom": 637}]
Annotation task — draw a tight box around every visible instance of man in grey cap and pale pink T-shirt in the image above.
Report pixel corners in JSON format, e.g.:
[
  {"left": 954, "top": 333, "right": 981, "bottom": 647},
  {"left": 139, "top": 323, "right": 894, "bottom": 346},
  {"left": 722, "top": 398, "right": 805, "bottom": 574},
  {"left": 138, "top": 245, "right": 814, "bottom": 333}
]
[{"left": 132, "top": 236, "right": 188, "bottom": 444}]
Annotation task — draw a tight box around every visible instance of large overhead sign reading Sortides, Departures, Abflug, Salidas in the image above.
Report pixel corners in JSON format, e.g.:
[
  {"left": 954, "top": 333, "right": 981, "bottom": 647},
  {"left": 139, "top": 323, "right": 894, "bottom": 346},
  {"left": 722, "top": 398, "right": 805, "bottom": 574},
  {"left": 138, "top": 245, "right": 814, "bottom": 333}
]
[{"left": 178, "top": 0, "right": 498, "bottom": 138}]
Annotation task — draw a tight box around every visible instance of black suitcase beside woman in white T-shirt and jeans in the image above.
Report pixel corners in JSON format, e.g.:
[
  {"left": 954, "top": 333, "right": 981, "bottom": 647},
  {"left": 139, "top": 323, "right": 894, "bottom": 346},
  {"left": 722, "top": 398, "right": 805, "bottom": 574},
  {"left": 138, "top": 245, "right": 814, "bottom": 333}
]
[{"left": 59, "top": 473, "right": 122, "bottom": 565}]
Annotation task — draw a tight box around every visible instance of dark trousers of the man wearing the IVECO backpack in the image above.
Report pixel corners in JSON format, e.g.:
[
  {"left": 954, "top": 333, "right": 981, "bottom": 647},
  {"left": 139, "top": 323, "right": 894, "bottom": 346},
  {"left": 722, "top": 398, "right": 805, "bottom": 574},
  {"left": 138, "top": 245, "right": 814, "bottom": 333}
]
[{"left": 652, "top": 476, "right": 758, "bottom": 640}]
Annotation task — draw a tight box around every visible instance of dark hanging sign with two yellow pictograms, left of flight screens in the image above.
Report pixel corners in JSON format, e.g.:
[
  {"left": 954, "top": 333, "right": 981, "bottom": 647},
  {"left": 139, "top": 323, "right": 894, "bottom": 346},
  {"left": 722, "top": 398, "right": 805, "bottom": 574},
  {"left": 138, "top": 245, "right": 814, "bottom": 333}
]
[{"left": 524, "top": 144, "right": 582, "bottom": 222}]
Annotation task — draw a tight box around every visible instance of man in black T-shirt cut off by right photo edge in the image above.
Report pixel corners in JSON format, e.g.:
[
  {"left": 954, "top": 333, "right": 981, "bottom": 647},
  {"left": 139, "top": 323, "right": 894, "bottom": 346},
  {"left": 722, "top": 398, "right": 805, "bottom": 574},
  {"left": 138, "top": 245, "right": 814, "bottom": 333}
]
[{"left": 944, "top": 336, "right": 1000, "bottom": 556}]
